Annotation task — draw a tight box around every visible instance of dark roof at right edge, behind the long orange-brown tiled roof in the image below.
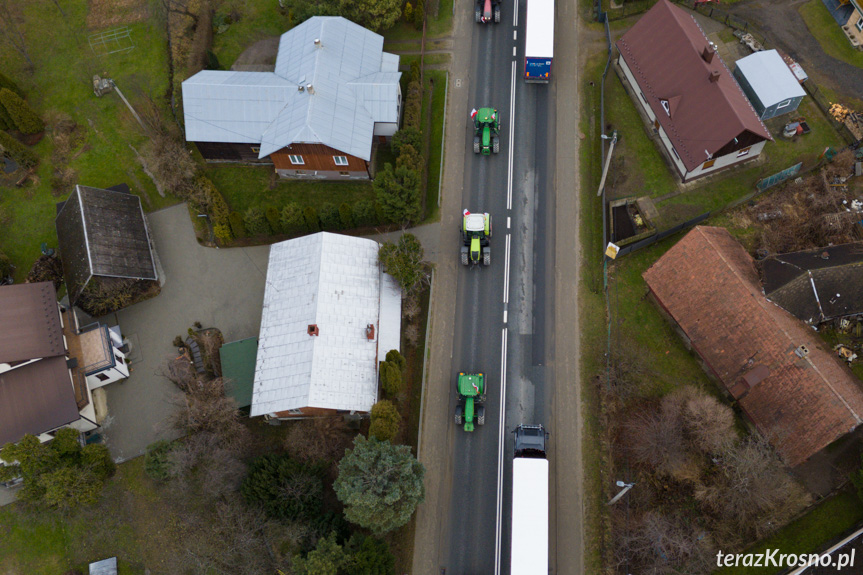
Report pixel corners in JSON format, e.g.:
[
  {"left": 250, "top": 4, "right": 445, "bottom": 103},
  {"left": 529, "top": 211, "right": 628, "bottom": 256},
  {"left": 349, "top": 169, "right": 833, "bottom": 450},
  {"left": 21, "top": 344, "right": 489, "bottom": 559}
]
[{"left": 761, "top": 242, "right": 863, "bottom": 325}]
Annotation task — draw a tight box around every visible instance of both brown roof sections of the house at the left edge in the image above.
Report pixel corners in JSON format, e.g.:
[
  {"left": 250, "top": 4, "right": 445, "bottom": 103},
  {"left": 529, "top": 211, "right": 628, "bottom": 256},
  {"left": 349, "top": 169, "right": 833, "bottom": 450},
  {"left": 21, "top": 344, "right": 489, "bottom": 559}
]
[{"left": 0, "top": 282, "right": 80, "bottom": 446}]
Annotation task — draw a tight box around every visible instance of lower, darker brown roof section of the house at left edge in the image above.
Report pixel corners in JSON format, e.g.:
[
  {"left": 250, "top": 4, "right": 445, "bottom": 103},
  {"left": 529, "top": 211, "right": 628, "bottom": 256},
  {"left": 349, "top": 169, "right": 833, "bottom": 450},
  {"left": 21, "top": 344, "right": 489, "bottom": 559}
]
[{"left": 0, "top": 356, "right": 80, "bottom": 446}]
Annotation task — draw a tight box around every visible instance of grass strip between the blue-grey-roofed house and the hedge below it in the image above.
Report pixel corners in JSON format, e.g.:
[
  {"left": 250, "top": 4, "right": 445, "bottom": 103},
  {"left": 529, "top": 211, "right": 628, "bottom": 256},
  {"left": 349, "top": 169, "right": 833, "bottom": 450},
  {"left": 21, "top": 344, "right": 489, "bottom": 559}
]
[{"left": 204, "top": 164, "right": 374, "bottom": 213}]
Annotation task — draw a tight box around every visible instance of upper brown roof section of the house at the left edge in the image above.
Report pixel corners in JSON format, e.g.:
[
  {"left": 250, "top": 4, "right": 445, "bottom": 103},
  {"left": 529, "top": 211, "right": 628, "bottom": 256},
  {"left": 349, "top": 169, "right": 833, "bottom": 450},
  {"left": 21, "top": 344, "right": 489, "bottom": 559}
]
[{"left": 0, "top": 282, "right": 66, "bottom": 363}]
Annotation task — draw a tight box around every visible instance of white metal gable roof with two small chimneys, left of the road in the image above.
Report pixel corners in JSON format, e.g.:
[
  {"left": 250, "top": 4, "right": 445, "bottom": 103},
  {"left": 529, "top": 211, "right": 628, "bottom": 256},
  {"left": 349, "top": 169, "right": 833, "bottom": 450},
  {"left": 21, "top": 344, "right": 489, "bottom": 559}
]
[{"left": 251, "top": 232, "right": 401, "bottom": 416}]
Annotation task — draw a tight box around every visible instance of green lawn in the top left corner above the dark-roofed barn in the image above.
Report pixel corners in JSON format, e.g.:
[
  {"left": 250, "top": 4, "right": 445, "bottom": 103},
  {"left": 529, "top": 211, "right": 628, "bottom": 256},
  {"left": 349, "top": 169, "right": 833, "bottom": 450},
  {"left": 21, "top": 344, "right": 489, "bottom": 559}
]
[{"left": 0, "top": 0, "right": 176, "bottom": 282}]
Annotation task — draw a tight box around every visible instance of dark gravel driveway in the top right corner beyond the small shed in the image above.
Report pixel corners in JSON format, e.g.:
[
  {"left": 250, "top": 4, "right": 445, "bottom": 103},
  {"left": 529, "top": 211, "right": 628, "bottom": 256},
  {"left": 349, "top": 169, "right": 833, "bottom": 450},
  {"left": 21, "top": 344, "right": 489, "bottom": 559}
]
[{"left": 721, "top": 0, "right": 863, "bottom": 98}]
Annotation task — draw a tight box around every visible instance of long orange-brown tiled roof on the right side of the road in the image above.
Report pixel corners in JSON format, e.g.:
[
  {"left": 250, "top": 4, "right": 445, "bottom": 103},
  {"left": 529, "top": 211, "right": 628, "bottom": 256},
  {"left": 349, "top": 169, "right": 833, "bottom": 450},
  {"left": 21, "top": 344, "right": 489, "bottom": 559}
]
[{"left": 644, "top": 226, "right": 863, "bottom": 466}]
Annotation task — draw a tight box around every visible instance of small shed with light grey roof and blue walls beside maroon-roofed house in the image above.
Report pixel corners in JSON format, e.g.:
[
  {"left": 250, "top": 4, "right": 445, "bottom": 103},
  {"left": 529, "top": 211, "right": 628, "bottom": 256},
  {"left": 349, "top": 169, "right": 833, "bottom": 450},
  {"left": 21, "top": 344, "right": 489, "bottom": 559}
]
[{"left": 734, "top": 50, "right": 806, "bottom": 120}]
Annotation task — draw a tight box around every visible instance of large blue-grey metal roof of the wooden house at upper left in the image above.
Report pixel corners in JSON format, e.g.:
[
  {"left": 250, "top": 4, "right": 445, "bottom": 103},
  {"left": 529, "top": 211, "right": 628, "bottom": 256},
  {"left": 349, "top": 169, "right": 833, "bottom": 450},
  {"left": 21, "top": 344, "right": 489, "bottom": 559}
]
[{"left": 183, "top": 16, "right": 401, "bottom": 161}]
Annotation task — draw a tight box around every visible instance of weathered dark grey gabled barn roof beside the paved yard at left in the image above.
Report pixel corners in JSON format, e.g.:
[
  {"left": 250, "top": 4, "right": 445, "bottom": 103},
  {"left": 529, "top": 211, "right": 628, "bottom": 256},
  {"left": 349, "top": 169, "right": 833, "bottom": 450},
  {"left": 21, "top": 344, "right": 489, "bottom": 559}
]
[{"left": 56, "top": 186, "right": 158, "bottom": 304}]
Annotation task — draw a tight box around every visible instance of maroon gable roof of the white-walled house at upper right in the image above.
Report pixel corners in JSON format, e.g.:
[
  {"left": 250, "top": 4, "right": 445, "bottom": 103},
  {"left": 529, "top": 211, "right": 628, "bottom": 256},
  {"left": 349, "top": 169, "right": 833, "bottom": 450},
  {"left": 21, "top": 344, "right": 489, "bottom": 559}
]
[{"left": 617, "top": 0, "right": 771, "bottom": 171}]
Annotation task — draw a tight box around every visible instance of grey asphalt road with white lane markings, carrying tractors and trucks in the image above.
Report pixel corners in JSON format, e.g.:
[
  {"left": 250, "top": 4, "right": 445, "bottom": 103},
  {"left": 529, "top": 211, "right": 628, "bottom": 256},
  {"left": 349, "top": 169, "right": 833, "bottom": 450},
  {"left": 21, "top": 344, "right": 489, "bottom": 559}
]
[{"left": 442, "top": 2, "right": 555, "bottom": 575}]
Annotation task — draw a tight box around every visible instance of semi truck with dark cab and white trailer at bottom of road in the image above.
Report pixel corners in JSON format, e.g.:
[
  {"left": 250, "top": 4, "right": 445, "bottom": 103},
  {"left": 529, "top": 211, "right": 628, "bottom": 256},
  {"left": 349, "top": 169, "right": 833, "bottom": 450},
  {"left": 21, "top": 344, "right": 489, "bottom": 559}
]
[{"left": 510, "top": 425, "right": 548, "bottom": 575}]
